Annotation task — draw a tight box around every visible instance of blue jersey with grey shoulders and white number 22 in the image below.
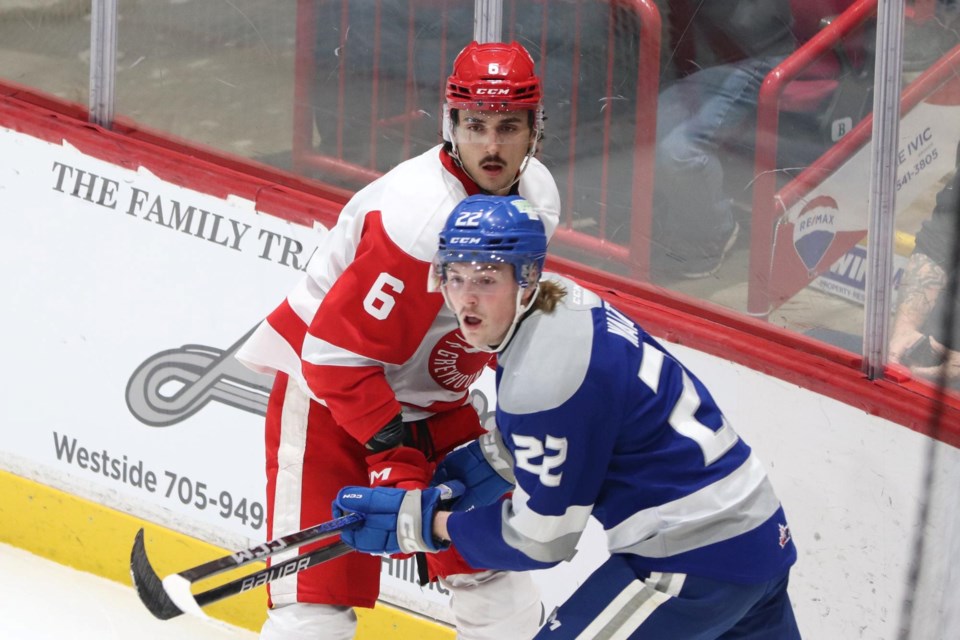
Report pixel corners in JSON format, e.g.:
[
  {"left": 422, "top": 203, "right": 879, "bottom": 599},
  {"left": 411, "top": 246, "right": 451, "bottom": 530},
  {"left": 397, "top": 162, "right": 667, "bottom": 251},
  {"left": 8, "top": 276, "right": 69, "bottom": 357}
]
[{"left": 448, "top": 276, "right": 796, "bottom": 583}]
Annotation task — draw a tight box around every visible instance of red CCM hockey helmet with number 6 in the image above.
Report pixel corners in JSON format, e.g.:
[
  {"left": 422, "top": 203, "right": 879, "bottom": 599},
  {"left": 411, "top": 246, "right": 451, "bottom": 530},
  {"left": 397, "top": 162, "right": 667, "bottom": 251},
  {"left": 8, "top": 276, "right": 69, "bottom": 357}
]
[{"left": 446, "top": 41, "right": 543, "bottom": 111}]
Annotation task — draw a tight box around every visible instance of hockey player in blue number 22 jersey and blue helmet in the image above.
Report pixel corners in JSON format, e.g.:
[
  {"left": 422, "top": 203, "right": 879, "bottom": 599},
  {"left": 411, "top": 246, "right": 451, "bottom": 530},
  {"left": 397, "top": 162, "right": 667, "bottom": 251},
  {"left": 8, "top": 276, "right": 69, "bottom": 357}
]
[{"left": 334, "top": 195, "right": 800, "bottom": 640}]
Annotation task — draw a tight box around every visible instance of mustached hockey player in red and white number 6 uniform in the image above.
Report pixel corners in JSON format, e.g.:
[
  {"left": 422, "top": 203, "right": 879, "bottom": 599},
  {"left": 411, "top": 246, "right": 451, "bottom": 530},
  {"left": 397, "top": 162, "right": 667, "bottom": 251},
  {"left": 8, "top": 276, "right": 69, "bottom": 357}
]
[{"left": 238, "top": 42, "right": 560, "bottom": 640}]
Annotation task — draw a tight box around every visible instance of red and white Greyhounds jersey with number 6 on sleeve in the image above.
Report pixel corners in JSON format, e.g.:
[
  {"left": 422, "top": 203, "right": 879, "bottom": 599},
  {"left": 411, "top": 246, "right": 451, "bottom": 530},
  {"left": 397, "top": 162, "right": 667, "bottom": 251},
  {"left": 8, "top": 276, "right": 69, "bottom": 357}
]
[{"left": 237, "top": 146, "right": 560, "bottom": 442}]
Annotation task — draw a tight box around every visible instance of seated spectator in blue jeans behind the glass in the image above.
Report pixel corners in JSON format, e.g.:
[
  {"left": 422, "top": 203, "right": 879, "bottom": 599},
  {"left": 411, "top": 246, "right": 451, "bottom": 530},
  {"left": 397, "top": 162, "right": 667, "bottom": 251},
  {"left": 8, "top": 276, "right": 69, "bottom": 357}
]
[{"left": 653, "top": 0, "right": 796, "bottom": 278}]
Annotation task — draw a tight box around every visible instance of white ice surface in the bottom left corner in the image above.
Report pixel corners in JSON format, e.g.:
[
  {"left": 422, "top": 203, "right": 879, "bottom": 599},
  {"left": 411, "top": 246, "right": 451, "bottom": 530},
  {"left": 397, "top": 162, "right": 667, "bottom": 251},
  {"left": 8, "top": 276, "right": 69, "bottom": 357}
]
[{"left": 0, "top": 544, "right": 257, "bottom": 640}]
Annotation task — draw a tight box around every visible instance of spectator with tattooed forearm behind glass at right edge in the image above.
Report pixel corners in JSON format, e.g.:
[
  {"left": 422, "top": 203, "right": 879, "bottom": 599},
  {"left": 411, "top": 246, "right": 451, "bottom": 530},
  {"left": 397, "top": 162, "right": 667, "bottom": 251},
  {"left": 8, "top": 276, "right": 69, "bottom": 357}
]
[{"left": 889, "top": 144, "right": 960, "bottom": 388}]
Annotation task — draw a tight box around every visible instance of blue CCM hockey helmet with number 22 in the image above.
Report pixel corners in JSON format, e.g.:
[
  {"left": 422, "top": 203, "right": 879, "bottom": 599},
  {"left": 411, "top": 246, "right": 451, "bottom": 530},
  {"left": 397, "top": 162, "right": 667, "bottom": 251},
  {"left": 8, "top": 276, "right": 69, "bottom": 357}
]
[{"left": 434, "top": 194, "right": 547, "bottom": 288}]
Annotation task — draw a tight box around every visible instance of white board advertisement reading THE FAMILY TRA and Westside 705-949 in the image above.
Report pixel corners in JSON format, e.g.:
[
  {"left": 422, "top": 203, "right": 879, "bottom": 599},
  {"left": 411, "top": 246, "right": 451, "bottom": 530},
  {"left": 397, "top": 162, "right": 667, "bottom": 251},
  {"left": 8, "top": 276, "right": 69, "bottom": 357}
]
[{"left": 0, "top": 128, "right": 605, "bottom": 622}]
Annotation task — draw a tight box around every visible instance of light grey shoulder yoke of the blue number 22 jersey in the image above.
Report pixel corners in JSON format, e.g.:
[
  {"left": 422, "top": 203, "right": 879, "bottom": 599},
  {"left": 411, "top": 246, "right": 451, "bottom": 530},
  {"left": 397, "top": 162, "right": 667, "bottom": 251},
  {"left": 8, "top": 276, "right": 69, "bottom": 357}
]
[{"left": 497, "top": 274, "right": 601, "bottom": 414}]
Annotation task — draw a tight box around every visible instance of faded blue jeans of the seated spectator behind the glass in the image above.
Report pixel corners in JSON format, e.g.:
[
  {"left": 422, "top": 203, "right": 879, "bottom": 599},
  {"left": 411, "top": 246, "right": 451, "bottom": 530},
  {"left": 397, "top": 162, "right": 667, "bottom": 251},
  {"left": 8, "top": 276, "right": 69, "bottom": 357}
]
[{"left": 653, "top": 56, "right": 784, "bottom": 272}]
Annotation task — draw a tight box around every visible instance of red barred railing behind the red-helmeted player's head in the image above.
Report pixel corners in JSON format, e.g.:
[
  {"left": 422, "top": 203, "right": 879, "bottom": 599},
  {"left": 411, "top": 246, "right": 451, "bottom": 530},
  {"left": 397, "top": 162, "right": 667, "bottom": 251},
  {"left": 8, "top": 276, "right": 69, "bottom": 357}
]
[{"left": 292, "top": 0, "right": 661, "bottom": 279}]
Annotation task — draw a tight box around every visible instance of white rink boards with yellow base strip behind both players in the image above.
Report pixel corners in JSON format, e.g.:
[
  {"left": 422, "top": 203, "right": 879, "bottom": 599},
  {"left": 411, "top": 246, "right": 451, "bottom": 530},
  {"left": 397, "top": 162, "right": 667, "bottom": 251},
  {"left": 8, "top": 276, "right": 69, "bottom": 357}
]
[{"left": 0, "top": 91, "right": 960, "bottom": 638}]
